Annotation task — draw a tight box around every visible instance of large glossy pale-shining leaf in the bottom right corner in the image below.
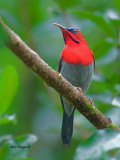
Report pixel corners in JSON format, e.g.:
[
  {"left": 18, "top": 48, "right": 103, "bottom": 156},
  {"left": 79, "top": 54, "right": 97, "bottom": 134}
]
[{"left": 74, "top": 129, "right": 120, "bottom": 160}]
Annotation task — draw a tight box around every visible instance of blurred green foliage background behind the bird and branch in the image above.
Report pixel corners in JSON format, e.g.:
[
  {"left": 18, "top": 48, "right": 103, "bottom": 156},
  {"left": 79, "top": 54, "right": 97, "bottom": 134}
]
[{"left": 0, "top": 0, "right": 120, "bottom": 160}]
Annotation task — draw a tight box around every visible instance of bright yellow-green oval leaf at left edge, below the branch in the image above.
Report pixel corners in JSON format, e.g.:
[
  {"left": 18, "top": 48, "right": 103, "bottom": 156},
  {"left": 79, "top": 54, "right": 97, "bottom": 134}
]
[{"left": 0, "top": 65, "right": 18, "bottom": 114}]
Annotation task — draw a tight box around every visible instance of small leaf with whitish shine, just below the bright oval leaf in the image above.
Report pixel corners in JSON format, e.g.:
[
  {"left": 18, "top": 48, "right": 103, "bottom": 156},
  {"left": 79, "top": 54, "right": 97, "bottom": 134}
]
[{"left": 0, "top": 114, "right": 16, "bottom": 125}]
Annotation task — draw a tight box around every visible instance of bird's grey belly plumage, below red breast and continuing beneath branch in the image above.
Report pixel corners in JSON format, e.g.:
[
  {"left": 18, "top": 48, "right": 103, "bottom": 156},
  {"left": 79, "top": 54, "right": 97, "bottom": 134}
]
[{"left": 60, "top": 61, "right": 94, "bottom": 116}]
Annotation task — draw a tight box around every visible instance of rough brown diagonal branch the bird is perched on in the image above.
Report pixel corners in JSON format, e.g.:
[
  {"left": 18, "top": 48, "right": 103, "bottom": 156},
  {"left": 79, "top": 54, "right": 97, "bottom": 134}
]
[{"left": 0, "top": 18, "right": 120, "bottom": 132}]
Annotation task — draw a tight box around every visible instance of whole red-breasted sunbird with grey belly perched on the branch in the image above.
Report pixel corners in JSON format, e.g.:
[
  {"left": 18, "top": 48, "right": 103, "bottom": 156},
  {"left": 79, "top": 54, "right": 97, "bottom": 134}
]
[{"left": 53, "top": 23, "right": 95, "bottom": 148}]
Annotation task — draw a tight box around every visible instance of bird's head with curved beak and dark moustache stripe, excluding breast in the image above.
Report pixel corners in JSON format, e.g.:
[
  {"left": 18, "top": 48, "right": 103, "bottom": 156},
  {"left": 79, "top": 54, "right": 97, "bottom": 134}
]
[{"left": 53, "top": 23, "right": 86, "bottom": 45}]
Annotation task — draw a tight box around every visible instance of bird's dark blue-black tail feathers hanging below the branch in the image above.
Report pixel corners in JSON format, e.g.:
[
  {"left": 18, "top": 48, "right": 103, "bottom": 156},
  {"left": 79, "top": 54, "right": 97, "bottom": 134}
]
[{"left": 61, "top": 110, "right": 74, "bottom": 147}]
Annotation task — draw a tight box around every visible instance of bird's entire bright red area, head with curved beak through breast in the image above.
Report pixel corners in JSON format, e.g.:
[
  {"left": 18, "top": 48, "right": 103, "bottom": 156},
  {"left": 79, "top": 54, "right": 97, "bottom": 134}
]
[{"left": 53, "top": 23, "right": 94, "bottom": 65}]
